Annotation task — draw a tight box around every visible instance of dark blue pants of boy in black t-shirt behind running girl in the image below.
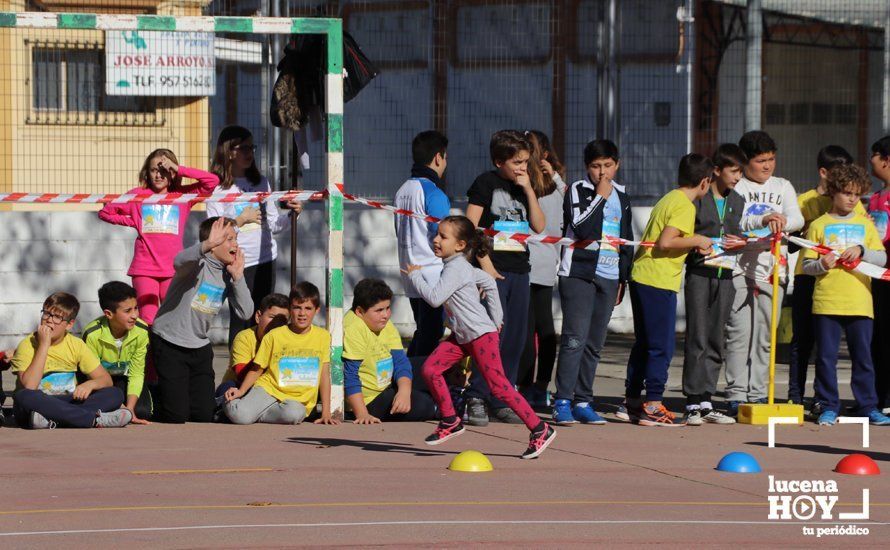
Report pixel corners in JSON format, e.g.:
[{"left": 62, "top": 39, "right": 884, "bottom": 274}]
[{"left": 464, "top": 271, "right": 531, "bottom": 409}]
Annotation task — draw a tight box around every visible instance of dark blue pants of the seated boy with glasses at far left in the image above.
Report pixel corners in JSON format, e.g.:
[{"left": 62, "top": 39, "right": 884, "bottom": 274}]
[{"left": 13, "top": 386, "right": 124, "bottom": 428}]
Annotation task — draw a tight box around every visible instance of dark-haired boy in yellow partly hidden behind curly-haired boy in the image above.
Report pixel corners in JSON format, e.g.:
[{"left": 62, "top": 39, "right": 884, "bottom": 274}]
[{"left": 788, "top": 145, "right": 868, "bottom": 404}]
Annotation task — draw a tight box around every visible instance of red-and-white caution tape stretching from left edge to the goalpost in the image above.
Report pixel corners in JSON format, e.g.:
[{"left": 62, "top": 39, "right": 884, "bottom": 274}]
[{"left": 0, "top": 191, "right": 327, "bottom": 204}]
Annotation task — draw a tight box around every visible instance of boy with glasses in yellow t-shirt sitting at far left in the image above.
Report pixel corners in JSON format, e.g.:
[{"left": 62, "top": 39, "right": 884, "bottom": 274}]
[{"left": 12, "top": 292, "right": 133, "bottom": 429}]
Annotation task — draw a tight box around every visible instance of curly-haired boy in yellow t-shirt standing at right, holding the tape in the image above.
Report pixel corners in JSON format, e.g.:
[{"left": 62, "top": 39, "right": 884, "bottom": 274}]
[{"left": 803, "top": 165, "right": 890, "bottom": 426}]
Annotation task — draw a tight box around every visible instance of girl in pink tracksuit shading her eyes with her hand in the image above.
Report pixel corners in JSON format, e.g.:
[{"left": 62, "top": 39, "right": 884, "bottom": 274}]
[{"left": 99, "top": 149, "right": 219, "bottom": 325}]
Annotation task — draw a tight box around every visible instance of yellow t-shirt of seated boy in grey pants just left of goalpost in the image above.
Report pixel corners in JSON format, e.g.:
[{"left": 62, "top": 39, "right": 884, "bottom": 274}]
[{"left": 253, "top": 325, "right": 331, "bottom": 412}]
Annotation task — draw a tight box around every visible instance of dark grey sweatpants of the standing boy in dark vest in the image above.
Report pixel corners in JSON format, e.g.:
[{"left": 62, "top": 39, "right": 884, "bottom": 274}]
[{"left": 683, "top": 273, "right": 736, "bottom": 405}]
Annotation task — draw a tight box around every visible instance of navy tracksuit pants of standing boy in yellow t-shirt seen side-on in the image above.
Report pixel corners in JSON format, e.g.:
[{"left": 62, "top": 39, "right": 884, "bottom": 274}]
[{"left": 626, "top": 281, "right": 677, "bottom": 401}]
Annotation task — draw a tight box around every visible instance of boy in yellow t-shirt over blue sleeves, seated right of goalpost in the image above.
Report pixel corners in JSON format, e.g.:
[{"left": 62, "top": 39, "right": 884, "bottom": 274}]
[{"left": 343, "top": 279, "right": 436, "bottom": 424}]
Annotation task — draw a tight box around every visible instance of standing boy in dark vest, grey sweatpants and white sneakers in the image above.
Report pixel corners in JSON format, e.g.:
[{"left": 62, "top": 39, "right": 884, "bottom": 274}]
[{"left": 683, "top": 143, "right": 747, "bottom": 426}]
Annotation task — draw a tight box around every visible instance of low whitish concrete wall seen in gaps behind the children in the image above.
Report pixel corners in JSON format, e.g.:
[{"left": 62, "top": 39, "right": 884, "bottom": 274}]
[{"left": 0, "top": 204, "right": 652, "bottom": 349}]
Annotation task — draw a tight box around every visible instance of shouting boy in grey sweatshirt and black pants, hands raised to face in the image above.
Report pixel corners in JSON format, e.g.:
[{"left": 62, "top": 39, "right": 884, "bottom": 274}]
[{"left": 151, "top": 218, "right": 253, "bottom": 424}]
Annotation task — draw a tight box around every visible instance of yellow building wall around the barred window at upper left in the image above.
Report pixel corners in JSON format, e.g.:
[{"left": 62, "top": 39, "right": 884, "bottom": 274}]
[{"left": 0, "top": 0, "right": 211, "bottom": 210}]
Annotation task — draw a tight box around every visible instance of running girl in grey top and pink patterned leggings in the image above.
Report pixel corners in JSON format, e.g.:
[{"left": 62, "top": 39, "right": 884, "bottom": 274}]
[{"left": 406, "top": 216, "right": 556, "bottom": 459}]
